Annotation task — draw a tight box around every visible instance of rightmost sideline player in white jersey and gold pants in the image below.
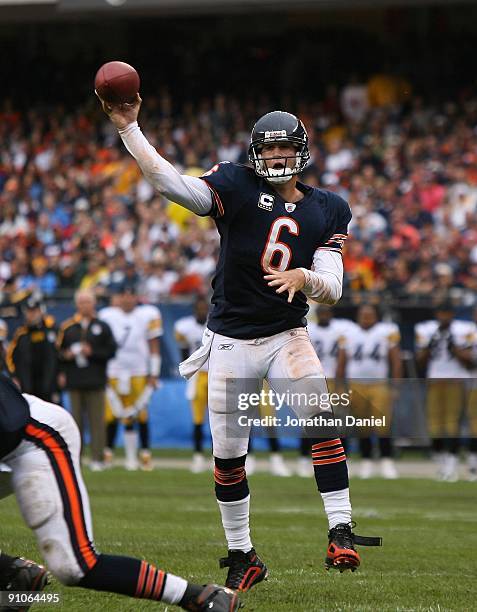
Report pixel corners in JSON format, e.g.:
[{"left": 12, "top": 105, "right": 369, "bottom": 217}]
[{"left": 415, "top": 301, "right": 476, "bottom": 482}]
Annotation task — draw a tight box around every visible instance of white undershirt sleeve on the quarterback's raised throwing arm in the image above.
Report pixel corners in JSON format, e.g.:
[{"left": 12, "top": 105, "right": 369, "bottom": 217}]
[{"left": 118, "top": 121, "right": 212, "bottom": 215}]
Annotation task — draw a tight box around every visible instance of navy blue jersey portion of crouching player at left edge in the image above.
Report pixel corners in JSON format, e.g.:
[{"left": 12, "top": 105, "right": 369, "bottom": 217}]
[{"left": 0, "top": 373, "right": 30, "bottom": 458}]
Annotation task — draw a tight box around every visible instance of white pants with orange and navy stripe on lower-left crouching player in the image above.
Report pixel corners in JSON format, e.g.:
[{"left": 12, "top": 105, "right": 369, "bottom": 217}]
[{"left": 3, "top": 394, "right": 95, "bottom": 584}]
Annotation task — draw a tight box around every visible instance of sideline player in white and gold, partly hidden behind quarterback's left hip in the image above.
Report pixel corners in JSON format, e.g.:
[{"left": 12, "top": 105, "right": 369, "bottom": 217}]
[{"left": 174, "top": 296, "right": 209, "bottom": 474}]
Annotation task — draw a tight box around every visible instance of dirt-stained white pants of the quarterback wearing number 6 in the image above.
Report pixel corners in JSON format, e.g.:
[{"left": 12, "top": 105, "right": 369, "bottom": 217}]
[{"left": 206, "top": 327, "right": 331, "bottom": 459}]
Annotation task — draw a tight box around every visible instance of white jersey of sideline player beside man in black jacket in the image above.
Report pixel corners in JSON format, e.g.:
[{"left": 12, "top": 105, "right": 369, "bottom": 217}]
[{"left": 99, "top": 304, "right": 162, "bottom": 378}]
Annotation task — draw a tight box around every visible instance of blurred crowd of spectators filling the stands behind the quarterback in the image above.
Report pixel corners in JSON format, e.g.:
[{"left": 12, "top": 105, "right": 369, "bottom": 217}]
[{"left": 0, "top": 74, "right": 477, "bottom": 305}]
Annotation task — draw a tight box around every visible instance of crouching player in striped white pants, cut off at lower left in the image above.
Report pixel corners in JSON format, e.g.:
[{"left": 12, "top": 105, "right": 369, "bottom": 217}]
[{"left": 0, "top": 374, "right": 239, "bottom": 612}]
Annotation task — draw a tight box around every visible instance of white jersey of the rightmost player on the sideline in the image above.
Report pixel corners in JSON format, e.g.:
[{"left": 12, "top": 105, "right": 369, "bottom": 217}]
[{"left": 415, "top": 320, "right": 477, "bottom": 378}]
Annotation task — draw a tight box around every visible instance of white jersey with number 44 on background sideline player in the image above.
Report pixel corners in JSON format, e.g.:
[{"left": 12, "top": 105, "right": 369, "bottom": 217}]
[{"left": 343, "top": 322, "right": 401, "bottom": 380}]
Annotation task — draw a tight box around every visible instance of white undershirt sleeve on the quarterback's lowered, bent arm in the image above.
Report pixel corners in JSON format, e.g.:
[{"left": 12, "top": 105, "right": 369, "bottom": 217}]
[{"left": 300, "top": 249, "right": 343, "bottom": 306}]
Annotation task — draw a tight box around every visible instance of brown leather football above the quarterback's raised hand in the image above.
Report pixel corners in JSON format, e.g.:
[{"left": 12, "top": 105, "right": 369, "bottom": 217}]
[{"left": 94, "top": 62, "right": 140, "bottom": 103}]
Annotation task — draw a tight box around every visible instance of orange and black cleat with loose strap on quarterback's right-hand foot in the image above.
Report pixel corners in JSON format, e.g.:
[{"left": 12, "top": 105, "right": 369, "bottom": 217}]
[{"left": 325, "top": 523, "right": 382, "bottom": 572}]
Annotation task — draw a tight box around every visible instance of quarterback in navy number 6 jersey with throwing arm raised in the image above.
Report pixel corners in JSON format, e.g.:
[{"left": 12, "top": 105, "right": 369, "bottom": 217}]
[{"left": 98, "top": 94, "right": 382, "bottom": 591}]
